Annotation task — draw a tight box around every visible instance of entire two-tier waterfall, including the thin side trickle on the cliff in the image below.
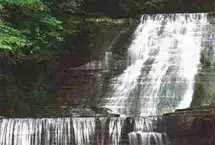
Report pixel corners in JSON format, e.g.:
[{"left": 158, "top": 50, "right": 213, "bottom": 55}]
[{"left": 0, "top": 13, "right": 212, "bottom": 145}]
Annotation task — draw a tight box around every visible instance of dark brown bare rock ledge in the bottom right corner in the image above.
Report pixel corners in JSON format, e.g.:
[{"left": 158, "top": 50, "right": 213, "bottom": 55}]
[{"left": 164, "top": 106, "right": 215, "bottom": 145}]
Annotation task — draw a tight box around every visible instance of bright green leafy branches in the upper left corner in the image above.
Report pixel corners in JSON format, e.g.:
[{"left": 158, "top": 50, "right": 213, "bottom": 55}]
[{"left": 0, "top": 0, "right": 84, "bottom": 61}]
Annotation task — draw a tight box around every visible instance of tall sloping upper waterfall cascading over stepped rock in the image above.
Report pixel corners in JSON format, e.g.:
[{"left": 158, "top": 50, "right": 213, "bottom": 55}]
[{"left": 99, "top": 13, "right": 208, "bottom": 116}]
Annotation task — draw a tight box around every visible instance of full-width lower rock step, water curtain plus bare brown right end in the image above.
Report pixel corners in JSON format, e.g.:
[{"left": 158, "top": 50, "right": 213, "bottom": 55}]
[{"left": 0, "top": 106, "right": 215, "bottom": 145}]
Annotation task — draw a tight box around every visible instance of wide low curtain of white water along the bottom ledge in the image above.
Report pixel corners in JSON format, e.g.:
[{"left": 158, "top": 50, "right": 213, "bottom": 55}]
[{"left": 0, "top": 117, "right": 164, "bottom": 145}]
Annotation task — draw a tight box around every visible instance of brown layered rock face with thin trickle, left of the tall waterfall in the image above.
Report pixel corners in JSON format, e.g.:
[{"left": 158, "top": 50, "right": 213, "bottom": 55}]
[{"left": 57, "top": 20, "right": 135, "bottom": 114}]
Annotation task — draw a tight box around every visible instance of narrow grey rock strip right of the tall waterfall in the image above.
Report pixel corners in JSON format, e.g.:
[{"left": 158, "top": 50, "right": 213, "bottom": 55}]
[{"left": 191, "top": 13, "right": 215, "bottom": 107}]
